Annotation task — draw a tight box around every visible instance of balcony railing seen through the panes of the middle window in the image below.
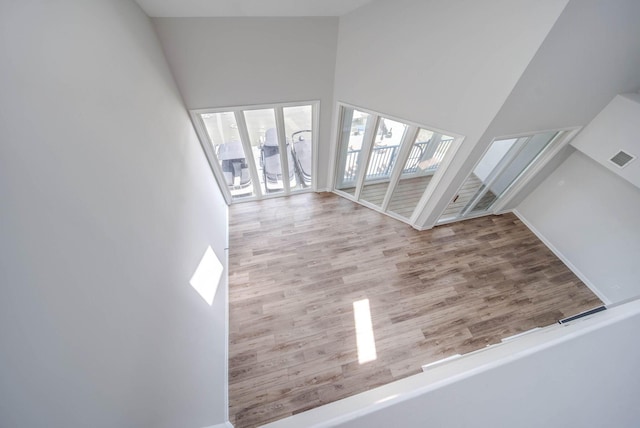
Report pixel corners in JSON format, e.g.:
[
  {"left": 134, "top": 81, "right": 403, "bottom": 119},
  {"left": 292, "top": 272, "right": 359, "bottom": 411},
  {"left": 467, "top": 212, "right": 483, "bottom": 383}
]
[{"left": 343, "top": 138, "right": 453, "bottom": 182}]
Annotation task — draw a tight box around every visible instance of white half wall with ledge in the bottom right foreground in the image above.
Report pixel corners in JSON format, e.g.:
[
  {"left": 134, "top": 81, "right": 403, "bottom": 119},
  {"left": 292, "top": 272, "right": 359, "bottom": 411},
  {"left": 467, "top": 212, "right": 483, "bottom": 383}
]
[{"left": 267, "top": 302, "right": 640, "bottom": 428}]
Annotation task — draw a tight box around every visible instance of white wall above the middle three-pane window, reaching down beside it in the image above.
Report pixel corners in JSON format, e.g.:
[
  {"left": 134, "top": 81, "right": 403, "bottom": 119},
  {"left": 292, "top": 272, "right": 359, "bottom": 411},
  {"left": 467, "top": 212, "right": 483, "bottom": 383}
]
[{"left": 335, "top": 0, "right": 567, "bottom": 227}]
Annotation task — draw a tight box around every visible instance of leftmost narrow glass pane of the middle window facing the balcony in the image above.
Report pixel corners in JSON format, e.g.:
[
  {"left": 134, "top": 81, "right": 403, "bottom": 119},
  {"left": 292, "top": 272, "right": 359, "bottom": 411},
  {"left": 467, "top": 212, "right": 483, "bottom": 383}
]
[{"left": 336, "top": 107, "right": 370, "bottom": 195}]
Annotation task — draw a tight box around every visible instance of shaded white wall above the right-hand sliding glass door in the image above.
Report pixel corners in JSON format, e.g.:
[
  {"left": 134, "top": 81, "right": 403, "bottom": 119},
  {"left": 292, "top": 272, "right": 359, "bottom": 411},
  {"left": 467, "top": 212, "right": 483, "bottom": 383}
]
[{"left": 470, "top": 0, "right": 640, "bottom": 213}]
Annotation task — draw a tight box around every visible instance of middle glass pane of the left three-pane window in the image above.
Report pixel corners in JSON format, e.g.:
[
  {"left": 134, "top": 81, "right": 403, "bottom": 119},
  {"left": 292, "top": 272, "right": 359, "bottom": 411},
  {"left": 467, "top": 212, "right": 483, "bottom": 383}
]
[{"left": 244, "top": 109, "right": 295, "bottom": 195}]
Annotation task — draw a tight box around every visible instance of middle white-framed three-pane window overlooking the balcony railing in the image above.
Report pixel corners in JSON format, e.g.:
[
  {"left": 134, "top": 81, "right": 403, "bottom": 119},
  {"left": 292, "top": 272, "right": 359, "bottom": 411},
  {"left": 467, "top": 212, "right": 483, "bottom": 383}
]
[{"left": 334, "top": 105, "right": 461, "bottom": 224}]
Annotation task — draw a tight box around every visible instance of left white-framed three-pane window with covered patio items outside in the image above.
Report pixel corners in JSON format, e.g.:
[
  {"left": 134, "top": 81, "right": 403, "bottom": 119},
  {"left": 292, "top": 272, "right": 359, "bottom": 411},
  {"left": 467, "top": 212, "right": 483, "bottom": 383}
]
[{"left": 191, "top": 102, "right": 318, "bottom": 203}]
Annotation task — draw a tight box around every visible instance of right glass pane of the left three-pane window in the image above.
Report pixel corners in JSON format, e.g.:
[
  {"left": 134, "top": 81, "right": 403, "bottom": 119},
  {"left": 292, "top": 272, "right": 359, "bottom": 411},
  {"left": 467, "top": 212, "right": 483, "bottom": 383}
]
[{"left": 282, "top": 105, "right": 313, "bottom": 190}]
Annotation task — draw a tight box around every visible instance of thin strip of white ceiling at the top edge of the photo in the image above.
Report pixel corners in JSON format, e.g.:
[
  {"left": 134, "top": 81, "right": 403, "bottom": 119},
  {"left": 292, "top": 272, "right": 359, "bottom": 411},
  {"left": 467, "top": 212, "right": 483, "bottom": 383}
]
[{"left": 136, "top": 0, "right": 372, "bottom": 17}]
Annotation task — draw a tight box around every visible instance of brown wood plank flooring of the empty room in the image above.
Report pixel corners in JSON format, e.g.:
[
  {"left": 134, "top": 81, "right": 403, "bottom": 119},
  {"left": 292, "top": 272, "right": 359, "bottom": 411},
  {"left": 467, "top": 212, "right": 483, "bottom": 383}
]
[{"left": 229, "top": 193, "right": 601, "bottom": 428}]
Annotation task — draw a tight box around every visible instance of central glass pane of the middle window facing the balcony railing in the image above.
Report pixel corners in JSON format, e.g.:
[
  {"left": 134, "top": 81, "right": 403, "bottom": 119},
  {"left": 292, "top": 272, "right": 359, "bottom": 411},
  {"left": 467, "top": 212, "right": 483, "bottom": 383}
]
[{"left": 360, "top": 118, "right": 407, "bottom": 206}]
